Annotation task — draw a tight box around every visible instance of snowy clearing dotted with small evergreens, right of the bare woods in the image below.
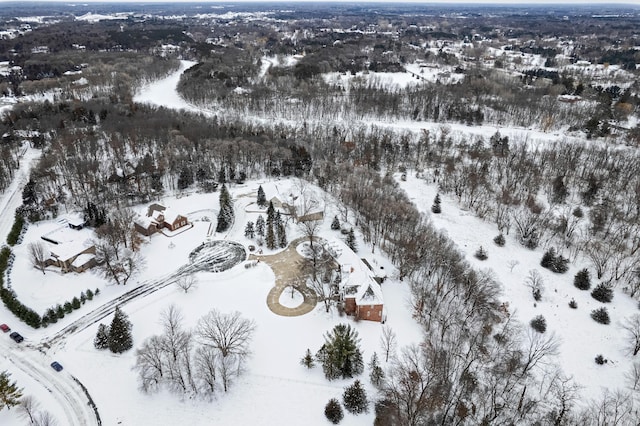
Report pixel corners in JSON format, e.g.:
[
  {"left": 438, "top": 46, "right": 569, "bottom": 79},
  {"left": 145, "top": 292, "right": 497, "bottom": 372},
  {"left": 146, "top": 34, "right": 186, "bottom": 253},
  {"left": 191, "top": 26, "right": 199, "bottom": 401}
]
[{"left": 398, "top": 173, "right": 638, "bottom": 403}]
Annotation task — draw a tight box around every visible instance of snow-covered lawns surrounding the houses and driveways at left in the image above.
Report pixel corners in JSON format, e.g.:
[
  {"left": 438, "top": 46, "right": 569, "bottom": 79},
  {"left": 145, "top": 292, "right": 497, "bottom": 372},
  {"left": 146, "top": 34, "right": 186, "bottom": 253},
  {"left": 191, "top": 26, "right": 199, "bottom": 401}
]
[{"left": 0, "top": 176, "right": 428, "bottom": 426}]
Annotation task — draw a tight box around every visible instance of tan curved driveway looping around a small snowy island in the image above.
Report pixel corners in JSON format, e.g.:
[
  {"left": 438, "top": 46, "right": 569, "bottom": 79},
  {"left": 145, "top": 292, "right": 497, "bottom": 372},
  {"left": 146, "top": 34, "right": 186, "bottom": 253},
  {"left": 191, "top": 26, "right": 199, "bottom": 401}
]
[{"left": 249, "top": 237, "right": 318, "bottom": 317}]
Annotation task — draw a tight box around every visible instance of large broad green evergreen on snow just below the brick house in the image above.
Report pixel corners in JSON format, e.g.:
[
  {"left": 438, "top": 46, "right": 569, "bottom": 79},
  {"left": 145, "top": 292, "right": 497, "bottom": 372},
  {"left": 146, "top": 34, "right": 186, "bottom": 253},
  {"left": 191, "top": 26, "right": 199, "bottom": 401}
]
[{"left": 316, "top": 324, "right": 364, "bottom": 380}]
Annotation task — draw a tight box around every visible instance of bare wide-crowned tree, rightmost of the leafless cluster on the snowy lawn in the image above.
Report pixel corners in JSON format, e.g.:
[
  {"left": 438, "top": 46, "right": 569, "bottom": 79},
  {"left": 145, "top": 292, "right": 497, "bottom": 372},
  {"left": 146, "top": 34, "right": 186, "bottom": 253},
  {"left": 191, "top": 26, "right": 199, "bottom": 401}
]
[{"left": 196, "top": 309, "right": 256, "bottom": 357}]
